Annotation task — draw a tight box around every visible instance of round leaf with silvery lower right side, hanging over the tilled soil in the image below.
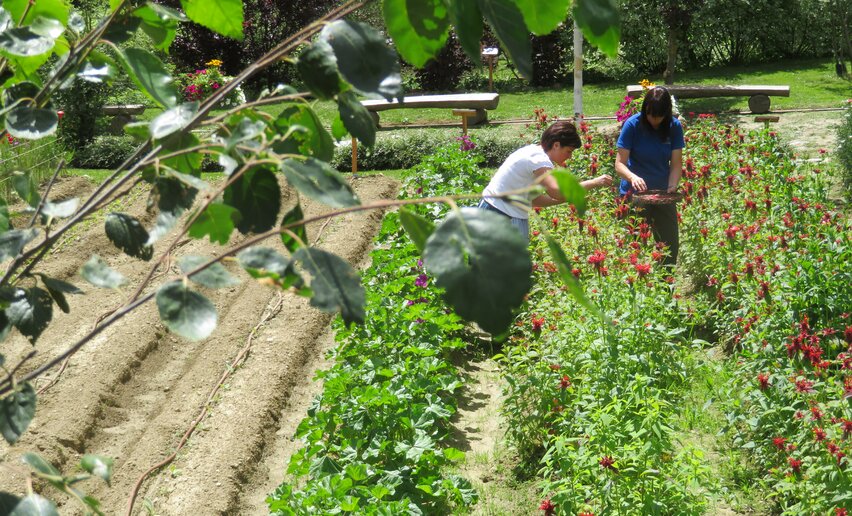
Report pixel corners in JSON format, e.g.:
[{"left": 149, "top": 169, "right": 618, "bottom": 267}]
[{"left": 157, "top": 281, "right": 217, "bottom": 340}]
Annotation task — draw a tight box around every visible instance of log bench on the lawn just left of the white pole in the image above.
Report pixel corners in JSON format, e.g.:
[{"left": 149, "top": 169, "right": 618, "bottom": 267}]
[{"left": 361, "top": 93, "right": 500, "bottom": 127}]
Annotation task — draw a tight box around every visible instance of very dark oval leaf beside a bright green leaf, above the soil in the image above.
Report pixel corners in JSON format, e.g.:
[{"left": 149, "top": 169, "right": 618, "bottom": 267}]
[{"left": 223, "top": 166, "right": 281, "bottom": 234}]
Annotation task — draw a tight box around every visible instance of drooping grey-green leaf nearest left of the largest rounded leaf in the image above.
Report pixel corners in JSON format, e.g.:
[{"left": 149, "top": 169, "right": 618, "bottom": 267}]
[{"left": 293, "top": 247, "right": 364, "bottom": 326}]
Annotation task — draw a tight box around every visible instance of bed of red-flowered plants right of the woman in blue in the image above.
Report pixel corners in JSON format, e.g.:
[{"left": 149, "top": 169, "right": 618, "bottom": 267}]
[{"left": 682, "top": 120, "right": 852, "bottom": 514}]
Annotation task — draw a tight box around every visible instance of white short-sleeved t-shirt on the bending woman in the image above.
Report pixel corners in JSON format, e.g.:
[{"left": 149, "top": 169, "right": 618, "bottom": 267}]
[{"left": 482, "top": 143, "right": 554, "bottom": 219}]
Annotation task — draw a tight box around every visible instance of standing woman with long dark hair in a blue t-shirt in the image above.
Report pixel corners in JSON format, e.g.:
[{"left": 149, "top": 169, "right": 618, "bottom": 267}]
[{"left": 615, "top": 86, "right": 684, "bottom": 265}]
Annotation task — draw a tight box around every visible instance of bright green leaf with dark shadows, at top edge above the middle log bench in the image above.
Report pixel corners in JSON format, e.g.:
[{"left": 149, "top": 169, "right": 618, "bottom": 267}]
[{"left": 382, "top": 0, "right": 450, "bottom": 68}]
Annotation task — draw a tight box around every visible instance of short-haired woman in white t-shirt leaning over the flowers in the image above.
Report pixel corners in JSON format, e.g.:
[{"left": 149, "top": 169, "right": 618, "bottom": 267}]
[{"left": 479, "top": 120, "right": 612, "bottom": 240}]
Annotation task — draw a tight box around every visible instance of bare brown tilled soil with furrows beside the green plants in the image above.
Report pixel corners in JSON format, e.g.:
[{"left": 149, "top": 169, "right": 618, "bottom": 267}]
[{"left": 0, "top": 172, "right": 397, "bottom": 514}]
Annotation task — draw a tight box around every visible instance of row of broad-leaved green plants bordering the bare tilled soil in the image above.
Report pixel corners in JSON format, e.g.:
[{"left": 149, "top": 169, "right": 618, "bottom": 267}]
[{"left": 267, "top": 144, "right": 490, "bottom": 514}]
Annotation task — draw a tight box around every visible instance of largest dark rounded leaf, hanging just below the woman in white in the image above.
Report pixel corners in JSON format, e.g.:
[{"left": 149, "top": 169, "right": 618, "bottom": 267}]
[{"left": 423, "top": 208, "right": 532, "bottom": 334}]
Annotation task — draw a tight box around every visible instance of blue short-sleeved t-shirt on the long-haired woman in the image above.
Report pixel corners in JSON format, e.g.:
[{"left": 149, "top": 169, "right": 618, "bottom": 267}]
[{"left": 618, "top": 113, "right": 684, "bottom": 195}]
